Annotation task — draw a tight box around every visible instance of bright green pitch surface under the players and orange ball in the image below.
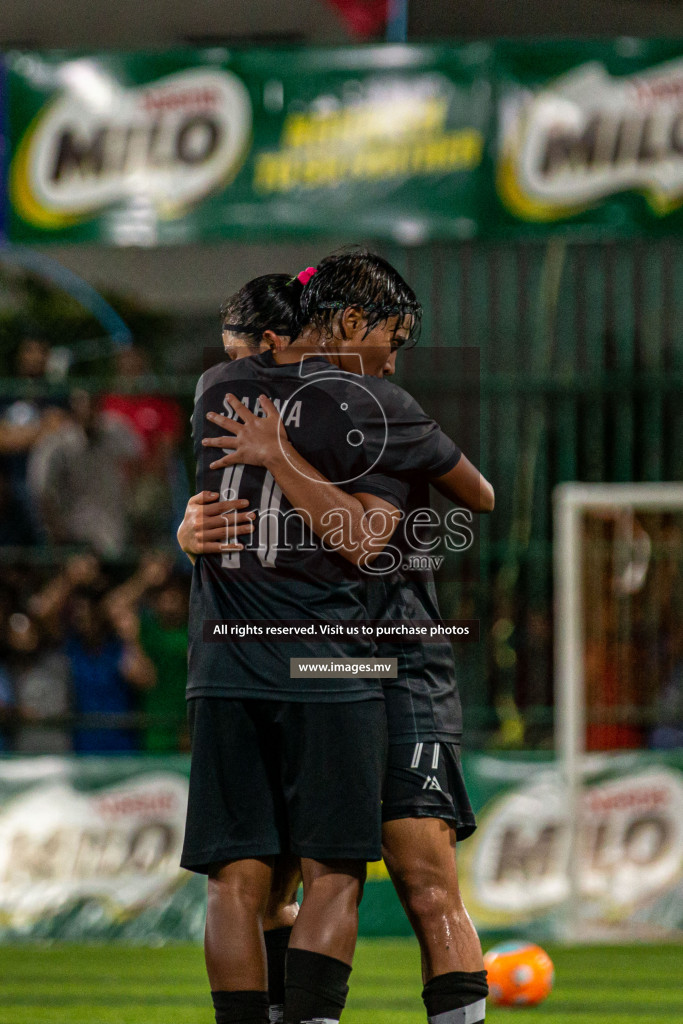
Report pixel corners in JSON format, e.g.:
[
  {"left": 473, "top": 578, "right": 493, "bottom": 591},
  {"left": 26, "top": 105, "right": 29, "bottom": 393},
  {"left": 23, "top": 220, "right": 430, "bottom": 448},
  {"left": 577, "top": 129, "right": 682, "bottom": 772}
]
[{"left": 0, "top": 939, "right": 683, "bottom": 1024}]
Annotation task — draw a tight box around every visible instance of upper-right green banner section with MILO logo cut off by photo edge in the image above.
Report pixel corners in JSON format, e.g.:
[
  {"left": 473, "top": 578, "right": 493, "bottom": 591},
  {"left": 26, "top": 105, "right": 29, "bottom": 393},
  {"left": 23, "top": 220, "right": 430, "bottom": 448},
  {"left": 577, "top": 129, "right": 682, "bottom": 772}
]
[{"left": 496, "top": 39, "right": 683, "bottom": 233}]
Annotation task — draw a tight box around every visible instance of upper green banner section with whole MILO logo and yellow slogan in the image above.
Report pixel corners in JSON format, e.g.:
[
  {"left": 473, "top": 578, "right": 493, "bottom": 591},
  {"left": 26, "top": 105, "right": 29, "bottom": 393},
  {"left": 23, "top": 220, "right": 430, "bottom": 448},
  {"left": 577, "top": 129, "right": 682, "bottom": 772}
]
[{"left": 2, "top": 44, "right": 493, "bottom": 245}]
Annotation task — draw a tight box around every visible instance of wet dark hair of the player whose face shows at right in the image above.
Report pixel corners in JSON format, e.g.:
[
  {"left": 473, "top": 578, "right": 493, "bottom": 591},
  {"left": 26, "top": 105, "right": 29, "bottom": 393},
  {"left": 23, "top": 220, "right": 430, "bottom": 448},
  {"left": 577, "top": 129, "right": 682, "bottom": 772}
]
[{"left": 298, "top": 248, "right": 422, "bottom": 342}]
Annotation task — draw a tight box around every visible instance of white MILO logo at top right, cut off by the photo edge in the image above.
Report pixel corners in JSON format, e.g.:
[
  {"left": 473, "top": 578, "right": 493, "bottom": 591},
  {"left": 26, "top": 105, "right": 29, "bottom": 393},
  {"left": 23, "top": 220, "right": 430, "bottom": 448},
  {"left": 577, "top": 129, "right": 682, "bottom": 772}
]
[{"left": 498, "top": 60, "right": 683, "bottom": 220}]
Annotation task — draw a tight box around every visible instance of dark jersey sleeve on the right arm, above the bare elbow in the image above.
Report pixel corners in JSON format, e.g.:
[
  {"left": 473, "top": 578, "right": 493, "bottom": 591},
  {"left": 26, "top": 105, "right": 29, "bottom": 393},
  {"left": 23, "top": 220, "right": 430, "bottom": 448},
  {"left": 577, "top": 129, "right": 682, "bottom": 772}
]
[{"left": 373, "top": 381, "right": 462, "bottom": 477}]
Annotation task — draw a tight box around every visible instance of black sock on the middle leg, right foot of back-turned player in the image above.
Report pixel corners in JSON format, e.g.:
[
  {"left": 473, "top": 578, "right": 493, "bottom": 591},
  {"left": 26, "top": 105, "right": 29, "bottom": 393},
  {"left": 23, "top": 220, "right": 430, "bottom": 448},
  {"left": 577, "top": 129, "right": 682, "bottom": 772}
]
[{"left": 285, "top": 949, "right": 351, "bottom": 1024}]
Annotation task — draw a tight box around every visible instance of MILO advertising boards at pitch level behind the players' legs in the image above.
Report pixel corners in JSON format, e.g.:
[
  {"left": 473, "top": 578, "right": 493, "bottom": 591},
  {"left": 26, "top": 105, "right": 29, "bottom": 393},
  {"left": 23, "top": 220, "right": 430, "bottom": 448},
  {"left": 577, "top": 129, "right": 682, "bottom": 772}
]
[{"left": 0, "top": 752, "right": 683, "bottom": 944}]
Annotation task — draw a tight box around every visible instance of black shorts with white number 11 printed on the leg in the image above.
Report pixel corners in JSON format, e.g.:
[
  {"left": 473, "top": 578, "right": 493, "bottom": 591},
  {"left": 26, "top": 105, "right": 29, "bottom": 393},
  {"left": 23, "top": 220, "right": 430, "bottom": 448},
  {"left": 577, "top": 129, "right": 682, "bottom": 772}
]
[{"left": 382, "top": 741, "right": 476, "bottom": 841}]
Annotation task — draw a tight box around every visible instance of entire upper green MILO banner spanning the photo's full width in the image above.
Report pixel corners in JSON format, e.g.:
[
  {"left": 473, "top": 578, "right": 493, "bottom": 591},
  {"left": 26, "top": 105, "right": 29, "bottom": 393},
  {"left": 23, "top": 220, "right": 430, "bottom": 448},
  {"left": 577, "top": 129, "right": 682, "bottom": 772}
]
[{"left": 6, "top": 39, "right": 683, "bottom": 245}]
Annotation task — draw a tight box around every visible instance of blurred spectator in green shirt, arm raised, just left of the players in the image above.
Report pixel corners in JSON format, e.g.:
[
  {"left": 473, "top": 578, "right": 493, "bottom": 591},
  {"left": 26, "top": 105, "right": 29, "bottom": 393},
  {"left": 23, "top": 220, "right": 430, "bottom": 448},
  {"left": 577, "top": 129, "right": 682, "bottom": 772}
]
[{"left": 110, "top": 555, "right": 189, "bottom": 754}]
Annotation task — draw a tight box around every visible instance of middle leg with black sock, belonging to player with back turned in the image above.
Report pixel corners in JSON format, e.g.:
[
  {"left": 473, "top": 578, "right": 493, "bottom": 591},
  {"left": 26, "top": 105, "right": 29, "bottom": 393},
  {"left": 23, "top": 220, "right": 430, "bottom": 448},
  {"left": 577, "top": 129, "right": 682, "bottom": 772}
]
[{"left": 285, "top": 858, "right": 366, "bottom": 1024}]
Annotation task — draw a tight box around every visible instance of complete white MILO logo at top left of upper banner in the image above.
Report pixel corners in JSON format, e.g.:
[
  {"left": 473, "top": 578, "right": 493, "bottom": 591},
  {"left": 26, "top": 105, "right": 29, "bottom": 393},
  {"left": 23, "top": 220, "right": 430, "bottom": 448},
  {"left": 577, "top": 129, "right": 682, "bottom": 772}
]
[{"left": 10, "top": 66, "right": 252, "bottom": 229}]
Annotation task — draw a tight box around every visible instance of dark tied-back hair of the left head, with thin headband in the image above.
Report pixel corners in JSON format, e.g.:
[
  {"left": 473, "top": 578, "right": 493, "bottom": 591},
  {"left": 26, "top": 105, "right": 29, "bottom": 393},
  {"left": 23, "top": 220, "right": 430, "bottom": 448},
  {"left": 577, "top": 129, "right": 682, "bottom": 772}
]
[{"left": 220, "top": 273, "right": 303, "bottom": 351}]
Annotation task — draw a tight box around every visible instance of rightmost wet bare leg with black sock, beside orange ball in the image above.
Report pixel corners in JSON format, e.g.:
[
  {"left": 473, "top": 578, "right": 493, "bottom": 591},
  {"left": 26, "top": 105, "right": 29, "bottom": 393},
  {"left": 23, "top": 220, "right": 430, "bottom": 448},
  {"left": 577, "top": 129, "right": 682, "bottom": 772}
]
[{"left": 382, "top": 818, "right": 487, "bottom": 1024}]
